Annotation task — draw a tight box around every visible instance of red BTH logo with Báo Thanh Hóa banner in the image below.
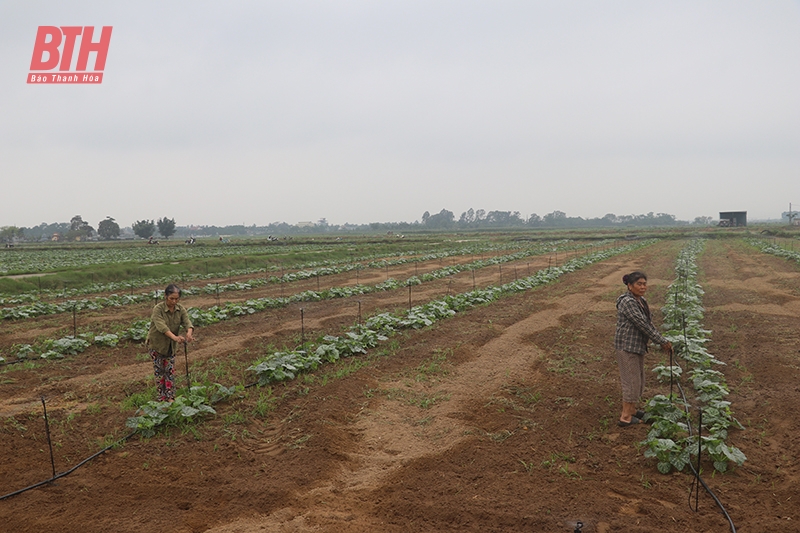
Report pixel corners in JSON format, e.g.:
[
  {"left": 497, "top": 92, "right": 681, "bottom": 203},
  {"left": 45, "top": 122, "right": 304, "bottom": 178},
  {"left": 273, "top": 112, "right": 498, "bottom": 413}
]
[{"left": 28, "top": 26, "right": 112, "bottom": 84}]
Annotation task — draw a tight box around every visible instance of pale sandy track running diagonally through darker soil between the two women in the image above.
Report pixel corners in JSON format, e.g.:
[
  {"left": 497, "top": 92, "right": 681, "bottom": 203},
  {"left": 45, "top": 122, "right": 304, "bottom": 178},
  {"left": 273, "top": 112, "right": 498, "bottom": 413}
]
[{"left": 203, "top": 263, "right": 634, "bottom": 533}]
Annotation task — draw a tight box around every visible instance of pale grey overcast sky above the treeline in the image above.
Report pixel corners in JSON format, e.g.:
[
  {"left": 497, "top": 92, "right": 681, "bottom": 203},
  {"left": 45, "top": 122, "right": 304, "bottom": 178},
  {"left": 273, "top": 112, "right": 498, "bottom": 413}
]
[{"left": 0, "top": 0, "right": 800, "bottom": 228}]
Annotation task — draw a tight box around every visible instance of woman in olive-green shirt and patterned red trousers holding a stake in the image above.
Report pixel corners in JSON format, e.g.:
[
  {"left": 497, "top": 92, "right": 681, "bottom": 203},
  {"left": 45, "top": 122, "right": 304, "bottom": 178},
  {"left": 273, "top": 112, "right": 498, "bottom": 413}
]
[{"left": 146, "top": 283, "right": 194, "bottom": 402}]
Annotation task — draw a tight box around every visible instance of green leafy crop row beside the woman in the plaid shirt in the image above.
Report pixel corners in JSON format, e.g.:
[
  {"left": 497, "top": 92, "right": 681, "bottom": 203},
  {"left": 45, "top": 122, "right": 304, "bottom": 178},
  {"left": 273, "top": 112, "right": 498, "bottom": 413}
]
[{"left": 641, "top": 239, "right": 746, "bottom": 474}]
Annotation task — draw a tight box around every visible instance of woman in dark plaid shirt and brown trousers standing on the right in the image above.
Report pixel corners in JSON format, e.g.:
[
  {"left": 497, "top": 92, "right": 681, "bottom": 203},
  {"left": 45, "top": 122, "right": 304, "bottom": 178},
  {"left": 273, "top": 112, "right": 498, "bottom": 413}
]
[{"left": 614, "top": 271, "right": 672, "bottom": 427}]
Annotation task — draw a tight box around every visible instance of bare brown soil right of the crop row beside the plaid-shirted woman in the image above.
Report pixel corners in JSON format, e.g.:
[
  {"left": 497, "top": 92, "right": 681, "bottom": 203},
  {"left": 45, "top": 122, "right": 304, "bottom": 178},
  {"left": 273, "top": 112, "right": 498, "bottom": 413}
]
[{"left": 701, "top": 241, "right": 800, "bottom": 531}]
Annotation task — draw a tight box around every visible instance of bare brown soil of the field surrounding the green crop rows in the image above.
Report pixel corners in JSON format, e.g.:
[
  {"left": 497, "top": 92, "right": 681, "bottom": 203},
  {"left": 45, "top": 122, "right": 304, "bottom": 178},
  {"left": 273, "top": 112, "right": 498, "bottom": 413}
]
[{"left": 0, "top": 238, "right": 800, "bottom": 533}]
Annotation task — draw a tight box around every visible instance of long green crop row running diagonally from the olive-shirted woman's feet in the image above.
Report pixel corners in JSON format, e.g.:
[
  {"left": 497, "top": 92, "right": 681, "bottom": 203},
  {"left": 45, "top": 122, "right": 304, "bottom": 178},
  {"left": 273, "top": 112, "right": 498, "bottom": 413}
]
[{"left": 127, "top": 240, "right": 655, "bottom": 436}]
